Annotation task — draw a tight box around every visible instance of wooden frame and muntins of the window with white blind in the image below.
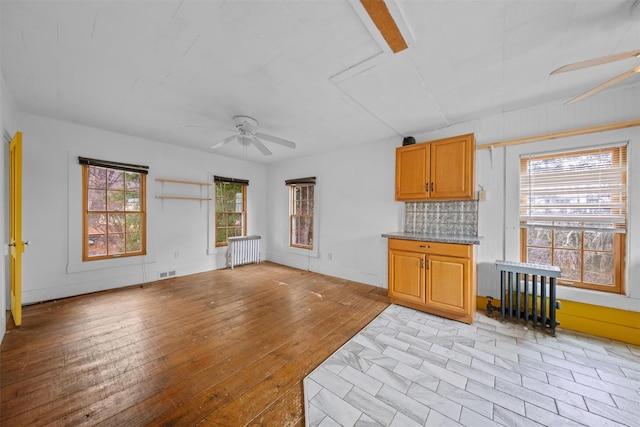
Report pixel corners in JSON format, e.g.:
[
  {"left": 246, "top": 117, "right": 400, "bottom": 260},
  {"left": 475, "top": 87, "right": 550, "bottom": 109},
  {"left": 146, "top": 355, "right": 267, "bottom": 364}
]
[{"left": 518, "top": 142, "right": 629, "bottom": 295}]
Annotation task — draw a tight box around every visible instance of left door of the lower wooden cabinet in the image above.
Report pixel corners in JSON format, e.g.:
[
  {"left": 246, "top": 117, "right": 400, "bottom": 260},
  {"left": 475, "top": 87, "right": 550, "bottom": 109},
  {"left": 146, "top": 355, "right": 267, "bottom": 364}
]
[{"left": 389, "top": 249, "right": 426, "bottom": 304}]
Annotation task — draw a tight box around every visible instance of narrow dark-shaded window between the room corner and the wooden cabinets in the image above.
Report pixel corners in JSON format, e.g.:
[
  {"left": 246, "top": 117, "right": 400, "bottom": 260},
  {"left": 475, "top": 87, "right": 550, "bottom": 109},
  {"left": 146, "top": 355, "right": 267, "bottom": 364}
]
[{"left": 285, "top": 177, "right": 316, "bottom": 249}]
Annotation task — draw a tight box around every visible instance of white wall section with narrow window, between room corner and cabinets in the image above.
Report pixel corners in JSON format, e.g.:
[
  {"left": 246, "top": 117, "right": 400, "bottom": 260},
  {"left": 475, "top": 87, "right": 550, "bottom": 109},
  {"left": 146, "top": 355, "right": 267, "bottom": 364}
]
[{"left": 268, "top": 139, "right": 403, "bottom": 287}]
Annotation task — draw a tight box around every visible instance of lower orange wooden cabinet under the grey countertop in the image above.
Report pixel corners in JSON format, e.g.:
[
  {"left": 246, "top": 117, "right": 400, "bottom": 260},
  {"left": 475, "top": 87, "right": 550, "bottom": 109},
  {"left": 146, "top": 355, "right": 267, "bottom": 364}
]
[{"left": 389, "top": 239, "right": 476, "bottom": 323}]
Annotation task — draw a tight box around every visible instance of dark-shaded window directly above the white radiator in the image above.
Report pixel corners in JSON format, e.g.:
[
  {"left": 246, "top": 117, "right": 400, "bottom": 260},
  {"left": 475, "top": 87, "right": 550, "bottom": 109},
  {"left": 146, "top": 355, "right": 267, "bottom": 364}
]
[{"left": 213, "top": 176, "right": 249, "bottom": 246}]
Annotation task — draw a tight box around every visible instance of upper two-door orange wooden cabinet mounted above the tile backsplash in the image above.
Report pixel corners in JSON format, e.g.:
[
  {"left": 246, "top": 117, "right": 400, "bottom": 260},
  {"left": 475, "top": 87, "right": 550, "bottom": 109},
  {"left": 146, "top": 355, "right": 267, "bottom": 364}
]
[{"left": 396, "top": 133, "right": 475, "bottom": 201}]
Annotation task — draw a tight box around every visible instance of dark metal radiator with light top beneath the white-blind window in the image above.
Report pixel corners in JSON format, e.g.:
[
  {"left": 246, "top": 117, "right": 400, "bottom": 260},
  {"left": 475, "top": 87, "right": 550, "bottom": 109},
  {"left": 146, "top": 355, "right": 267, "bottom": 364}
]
[{"left": 487, "top": 261, "right": 560, "bottom": 336}]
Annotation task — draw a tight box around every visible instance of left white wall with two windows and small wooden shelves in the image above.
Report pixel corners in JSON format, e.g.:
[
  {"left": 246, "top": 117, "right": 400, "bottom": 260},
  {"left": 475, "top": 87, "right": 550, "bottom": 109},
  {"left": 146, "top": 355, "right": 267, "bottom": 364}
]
[{"left": 17, "top": 113, "right": 267, "bottom": 304}]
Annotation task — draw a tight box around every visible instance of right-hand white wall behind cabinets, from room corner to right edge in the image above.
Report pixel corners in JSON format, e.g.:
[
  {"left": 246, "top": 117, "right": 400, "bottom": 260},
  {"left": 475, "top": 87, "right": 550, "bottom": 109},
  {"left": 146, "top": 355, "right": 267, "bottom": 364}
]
[{"left": 268, "top": 83, "right": 640, "bottom": 311}]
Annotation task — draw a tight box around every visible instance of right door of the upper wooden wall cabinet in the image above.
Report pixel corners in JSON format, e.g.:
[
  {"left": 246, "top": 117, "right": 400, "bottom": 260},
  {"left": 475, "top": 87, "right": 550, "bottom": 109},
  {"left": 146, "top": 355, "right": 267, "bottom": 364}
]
[{"left": 429, "top": 134, "right": 475, "bottom": 199}]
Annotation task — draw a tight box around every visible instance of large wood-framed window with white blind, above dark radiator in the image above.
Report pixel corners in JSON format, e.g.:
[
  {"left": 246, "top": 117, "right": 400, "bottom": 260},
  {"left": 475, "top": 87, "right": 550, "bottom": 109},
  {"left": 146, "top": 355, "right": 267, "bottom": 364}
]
[{"left": 520, "top": 145, "right": 627, "bottom": 293}]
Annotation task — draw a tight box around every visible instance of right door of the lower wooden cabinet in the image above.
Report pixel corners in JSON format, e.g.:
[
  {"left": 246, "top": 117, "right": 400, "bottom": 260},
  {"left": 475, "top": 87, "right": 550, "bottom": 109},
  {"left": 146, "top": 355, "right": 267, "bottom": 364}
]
[{"left": 426, "top": 255, "right": 471, "bottom": 314}]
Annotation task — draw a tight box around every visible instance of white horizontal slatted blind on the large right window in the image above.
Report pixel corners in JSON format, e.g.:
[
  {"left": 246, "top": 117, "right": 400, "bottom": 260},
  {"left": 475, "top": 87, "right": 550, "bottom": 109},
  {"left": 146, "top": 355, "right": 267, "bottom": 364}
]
[{"left": 520, "top": 144, "right": 627, "bottom": 231}]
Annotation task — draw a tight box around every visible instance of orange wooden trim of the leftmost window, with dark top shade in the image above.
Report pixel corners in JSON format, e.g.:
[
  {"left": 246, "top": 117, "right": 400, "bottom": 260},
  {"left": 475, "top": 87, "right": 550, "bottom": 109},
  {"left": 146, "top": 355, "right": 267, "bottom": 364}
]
[{"left": 78, "top": 157, "right": 149, "bottom": 262}]
